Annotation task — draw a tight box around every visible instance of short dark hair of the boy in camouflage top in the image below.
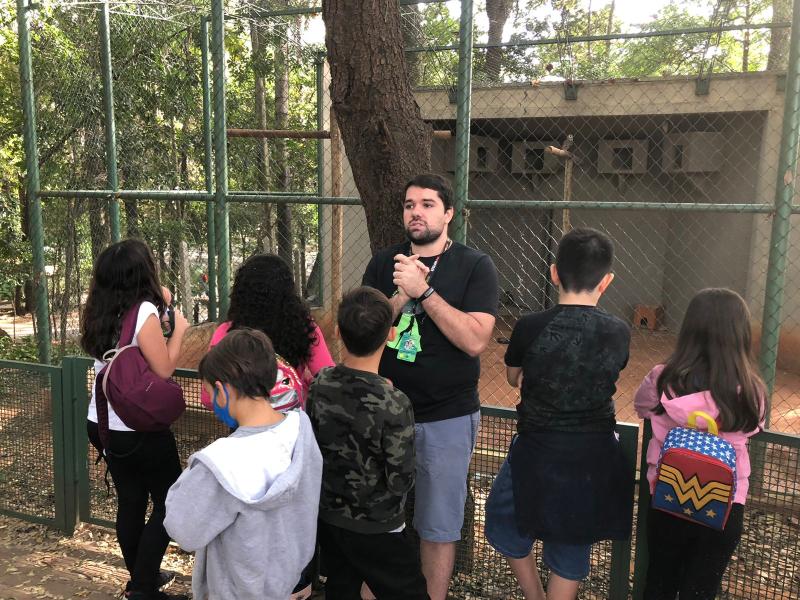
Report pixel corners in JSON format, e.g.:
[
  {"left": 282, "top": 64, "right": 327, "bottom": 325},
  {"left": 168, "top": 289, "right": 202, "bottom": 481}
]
[{"left": 336, "top": 286, "right": 393, "bottom": 356}]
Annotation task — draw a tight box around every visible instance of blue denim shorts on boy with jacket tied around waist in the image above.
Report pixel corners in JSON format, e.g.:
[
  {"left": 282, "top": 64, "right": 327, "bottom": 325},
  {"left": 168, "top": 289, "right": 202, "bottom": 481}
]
[{"left": 484, "top": 450, "right": 592, "bottom": 581}]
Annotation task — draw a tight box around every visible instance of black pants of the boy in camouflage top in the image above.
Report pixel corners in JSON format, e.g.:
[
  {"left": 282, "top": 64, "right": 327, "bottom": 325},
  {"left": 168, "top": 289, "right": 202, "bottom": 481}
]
[{"left": 317, "top": 521, "right": 429, "bottom": 600}]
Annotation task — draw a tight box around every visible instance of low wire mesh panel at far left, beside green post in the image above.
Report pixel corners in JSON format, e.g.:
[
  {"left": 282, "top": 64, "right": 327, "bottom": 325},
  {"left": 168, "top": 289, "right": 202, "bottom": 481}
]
[{"left": 0, "top": 361, "right": 61, "bottom": 524}]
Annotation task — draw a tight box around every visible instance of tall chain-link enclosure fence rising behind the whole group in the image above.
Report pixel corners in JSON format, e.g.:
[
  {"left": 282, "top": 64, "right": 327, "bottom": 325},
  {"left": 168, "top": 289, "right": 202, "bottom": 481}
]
[{"left": 10, "top": 0, "right": 800, "bottom": 431}]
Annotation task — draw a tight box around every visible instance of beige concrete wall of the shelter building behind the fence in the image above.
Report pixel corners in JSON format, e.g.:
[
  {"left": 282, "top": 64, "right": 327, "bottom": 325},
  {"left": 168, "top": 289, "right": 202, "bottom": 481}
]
[{"left": 322, "top": 74, "right": 800, "bottom": 342}]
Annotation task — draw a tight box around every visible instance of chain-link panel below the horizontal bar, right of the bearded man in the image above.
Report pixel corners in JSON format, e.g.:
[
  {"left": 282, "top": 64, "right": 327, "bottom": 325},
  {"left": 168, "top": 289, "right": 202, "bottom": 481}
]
[{"left": 468, "top": 203, "right": 772, "bottom": 426}]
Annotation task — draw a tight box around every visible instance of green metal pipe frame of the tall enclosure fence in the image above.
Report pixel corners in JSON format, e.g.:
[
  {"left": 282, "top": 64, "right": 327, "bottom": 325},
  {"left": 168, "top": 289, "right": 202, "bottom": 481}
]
[{"left": 17, "top": 0, "right": 800, "bottom": 412}]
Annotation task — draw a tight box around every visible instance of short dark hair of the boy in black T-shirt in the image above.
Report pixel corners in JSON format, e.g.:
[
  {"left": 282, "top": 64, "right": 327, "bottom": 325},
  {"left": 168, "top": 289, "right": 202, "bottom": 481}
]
[{"left": 556, "top": 227, "right": 614, "bottom": 292}]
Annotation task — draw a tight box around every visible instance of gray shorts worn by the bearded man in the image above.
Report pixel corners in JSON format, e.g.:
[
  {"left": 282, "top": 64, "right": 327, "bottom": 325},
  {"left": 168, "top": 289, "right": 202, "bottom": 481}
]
[{"left": 414, "top": 411, "right": 481, "bottom": 542}]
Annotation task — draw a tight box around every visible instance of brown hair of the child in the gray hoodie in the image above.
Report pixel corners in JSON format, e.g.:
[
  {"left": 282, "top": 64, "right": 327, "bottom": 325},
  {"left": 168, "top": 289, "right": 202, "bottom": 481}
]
[{"left": 197, "top": 328, "right": 278, "bottom": 398}]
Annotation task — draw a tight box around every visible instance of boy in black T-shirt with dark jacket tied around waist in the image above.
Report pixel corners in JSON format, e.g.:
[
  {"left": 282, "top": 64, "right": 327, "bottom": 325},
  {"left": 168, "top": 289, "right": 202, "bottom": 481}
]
[{"left": 486, "top": 228, "right": 633, "bottom": 600}]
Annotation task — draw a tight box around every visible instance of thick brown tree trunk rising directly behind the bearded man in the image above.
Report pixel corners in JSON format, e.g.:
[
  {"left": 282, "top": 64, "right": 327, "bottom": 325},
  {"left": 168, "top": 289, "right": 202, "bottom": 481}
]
[{"left": 322, "top": 0, "right": 431, "bottom": 253}]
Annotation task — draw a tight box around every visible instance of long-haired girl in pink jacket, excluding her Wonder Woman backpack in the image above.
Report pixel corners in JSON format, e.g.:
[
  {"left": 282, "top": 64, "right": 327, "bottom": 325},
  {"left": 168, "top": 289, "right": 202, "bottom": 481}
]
[{"left": 634, "top": 288, "right": 765, "bottom": 600}]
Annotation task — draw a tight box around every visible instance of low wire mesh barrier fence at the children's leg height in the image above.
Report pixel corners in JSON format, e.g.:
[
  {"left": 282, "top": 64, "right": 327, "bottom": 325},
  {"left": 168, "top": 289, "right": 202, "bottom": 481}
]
[{"left": 0, "top": 358, "right": 800, "bottom": 600}]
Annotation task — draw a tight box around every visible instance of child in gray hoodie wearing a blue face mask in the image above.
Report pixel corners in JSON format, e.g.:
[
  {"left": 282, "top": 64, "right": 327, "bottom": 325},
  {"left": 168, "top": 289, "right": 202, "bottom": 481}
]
[{"left": 164, "top": 329, "right": 322, "bottom": 600}]
